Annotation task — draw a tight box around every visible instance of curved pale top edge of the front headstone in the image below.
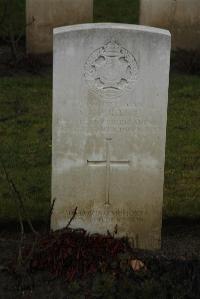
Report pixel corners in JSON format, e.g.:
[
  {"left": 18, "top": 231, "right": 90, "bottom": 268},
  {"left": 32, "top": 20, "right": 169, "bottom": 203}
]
[{"left": 53, "top": 23, "right": 171, "bottom": 37}]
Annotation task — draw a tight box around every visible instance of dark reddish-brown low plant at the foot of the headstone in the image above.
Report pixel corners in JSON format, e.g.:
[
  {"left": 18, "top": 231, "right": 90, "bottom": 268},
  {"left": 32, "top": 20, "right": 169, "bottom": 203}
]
[{"left": 23, "top": 228, "right": 131, "bottom": 281}]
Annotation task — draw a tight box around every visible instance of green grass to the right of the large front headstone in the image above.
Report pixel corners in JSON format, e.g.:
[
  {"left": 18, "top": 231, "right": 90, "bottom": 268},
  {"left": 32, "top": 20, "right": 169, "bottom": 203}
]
[{"left": 164, "top": 75, "right": 200, "bottom": 217}]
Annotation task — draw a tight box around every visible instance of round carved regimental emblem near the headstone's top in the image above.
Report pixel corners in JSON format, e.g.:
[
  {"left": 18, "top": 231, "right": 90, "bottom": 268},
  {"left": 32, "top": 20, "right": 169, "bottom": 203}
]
[{"left": 85, "top": 41, "right": 138, "bottom": 99}]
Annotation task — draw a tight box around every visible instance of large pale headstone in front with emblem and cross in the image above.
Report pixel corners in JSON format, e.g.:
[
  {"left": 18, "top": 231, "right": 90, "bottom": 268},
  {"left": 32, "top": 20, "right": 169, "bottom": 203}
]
[{"left": 51, "top": 24, "right": 170, "bottom": 249}]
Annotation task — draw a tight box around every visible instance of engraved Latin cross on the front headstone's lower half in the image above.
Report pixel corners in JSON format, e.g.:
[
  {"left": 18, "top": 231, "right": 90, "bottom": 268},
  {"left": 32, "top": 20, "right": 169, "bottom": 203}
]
[{"left": 87, "top": 138, "right": 130, "bottom": 205}]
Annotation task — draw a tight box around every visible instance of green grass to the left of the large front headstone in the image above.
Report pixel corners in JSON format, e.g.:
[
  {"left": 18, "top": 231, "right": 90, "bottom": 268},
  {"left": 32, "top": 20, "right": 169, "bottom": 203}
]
[{"left": 0, "top": 76, "right": 52, "bottom": 219}]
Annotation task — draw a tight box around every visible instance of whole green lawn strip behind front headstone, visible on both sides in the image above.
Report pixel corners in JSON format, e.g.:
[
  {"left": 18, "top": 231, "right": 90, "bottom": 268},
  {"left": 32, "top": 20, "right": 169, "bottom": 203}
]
[{"left": 0, "top": 74, "right": 200, "bottom": 220}]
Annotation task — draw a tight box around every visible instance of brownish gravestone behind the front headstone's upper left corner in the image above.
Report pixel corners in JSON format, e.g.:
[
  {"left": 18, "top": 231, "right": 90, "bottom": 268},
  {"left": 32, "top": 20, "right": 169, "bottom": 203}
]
[{"left": 26, "top": 0, "right": 93, "bottom": 54}]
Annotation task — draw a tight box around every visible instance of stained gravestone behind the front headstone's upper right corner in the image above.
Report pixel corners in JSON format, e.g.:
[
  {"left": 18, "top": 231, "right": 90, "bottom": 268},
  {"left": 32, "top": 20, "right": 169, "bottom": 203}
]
[{"left": 140, "top": 0, "right": 200, "bottom": 50}]
